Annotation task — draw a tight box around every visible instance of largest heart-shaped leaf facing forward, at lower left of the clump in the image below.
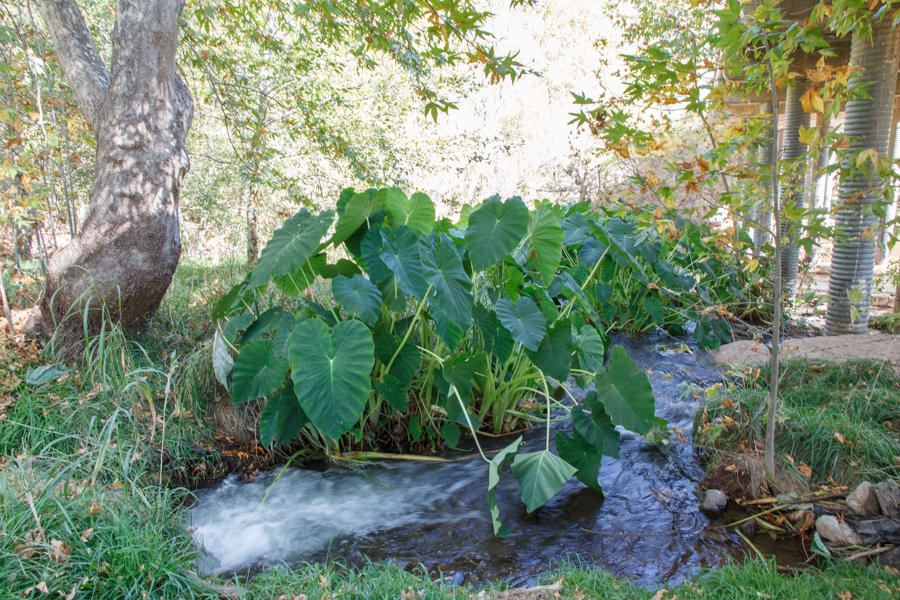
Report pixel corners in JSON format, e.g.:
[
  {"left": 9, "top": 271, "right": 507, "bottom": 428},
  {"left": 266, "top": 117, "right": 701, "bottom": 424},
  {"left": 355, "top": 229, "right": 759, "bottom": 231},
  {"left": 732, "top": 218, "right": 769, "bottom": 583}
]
[{"left": 290, "top": 319, "right": 375, "bottom": 439}]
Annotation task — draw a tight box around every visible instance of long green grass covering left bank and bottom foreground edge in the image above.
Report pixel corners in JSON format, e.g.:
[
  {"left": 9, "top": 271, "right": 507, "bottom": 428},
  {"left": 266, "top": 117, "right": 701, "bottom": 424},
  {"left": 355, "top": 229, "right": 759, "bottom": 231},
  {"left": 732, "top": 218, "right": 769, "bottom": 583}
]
[{"left": 0, "top": 263, "right": 900, "bottom": 600}]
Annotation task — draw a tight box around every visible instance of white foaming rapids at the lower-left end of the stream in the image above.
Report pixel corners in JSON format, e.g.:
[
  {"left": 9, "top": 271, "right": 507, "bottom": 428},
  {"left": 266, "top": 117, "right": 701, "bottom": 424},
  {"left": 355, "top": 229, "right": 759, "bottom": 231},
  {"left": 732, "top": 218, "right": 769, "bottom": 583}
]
[{"left": 189, "top": 461, "right": 489, "bottom": 573}]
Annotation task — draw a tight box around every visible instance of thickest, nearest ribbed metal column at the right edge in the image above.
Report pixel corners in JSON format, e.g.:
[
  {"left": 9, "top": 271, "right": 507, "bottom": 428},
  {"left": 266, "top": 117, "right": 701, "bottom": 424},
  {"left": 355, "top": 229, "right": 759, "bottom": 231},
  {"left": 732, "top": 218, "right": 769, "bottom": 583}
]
[{"left": 825, "top": 18, "right": 900, "bottom": 335}]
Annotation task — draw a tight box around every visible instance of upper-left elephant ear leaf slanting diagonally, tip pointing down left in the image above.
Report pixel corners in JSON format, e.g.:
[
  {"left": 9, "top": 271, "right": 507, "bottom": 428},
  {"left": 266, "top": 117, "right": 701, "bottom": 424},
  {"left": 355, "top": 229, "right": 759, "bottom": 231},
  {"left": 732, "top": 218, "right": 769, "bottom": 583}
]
[{"left": 249, "top": 208, "right": 334, "bottom": 288}]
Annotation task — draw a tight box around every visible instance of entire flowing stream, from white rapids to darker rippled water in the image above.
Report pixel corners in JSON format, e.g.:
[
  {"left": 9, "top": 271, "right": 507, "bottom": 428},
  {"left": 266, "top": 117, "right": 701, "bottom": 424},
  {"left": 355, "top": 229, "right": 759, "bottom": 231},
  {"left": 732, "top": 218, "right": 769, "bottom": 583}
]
[{"left": 190, "top": 336, "right": 802, "bottom": 585}]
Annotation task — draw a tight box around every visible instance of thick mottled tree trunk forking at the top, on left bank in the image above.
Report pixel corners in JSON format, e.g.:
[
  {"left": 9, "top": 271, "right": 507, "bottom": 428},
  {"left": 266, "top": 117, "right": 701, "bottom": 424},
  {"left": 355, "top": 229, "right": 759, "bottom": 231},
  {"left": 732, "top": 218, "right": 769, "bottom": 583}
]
[{"left": 32, "top": 0, "right": 193, "bottom": 352}]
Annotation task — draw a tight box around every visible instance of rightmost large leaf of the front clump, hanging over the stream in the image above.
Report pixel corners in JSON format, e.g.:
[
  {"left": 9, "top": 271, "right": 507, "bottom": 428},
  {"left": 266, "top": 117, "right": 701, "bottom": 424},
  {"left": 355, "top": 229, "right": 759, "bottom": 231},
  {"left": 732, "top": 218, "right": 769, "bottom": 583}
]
[{"left": 594, "top": 346, "right": 656, "bottom": 435}]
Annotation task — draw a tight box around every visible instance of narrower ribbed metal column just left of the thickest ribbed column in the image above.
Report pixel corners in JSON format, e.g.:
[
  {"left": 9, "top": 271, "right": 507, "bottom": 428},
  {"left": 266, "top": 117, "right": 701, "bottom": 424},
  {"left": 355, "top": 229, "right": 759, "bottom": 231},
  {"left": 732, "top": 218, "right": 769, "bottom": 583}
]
[{"left": 780, "top": 77, "right": 809, "bottom": 301}]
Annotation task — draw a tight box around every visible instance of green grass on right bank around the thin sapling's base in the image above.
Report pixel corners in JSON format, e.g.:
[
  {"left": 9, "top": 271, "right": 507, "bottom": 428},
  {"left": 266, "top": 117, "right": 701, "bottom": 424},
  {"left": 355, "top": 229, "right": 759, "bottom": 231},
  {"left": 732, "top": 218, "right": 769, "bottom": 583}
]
[{"left": 697, "top": 361, "right": 900, "bottom": 485}]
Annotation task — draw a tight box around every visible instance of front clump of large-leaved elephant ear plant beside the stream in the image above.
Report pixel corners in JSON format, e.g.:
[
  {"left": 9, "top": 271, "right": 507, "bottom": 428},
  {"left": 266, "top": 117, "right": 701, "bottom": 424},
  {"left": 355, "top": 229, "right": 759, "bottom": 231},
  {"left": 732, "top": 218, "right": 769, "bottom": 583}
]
[{"left": 212, "top": 188, "right": 658, "bottom": 536}]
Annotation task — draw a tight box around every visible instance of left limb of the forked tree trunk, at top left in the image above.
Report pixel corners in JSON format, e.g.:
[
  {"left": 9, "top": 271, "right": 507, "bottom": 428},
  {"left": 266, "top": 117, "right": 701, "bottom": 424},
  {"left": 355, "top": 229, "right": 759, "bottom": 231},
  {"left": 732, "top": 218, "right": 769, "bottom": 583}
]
[{"left": 37, "top": 0, "right": 109, "bottom": 129}]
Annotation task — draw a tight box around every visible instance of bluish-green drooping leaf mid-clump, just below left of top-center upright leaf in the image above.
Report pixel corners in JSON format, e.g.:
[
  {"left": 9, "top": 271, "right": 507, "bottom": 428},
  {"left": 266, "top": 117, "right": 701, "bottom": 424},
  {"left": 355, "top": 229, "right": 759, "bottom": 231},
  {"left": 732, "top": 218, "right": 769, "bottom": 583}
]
[{"left": 419, "top": 233, "right": 473, "bottom": 329}]
